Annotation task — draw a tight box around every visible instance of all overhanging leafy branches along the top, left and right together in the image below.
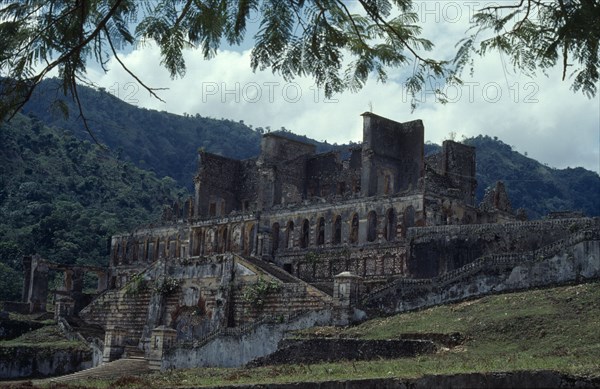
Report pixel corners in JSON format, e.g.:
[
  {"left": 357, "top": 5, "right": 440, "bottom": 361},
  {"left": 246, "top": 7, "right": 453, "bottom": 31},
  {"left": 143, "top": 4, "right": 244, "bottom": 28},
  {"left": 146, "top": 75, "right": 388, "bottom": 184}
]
[{"left": 0, "top": 0, "right": 600, "bottom": 133}]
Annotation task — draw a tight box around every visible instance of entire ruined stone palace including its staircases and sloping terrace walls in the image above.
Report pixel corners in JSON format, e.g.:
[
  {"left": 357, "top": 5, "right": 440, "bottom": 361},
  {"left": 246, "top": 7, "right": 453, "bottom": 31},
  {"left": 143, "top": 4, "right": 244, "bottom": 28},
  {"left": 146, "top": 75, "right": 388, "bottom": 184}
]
[{"left": 16, "top": 112, "right": 600, "bottom": 368}]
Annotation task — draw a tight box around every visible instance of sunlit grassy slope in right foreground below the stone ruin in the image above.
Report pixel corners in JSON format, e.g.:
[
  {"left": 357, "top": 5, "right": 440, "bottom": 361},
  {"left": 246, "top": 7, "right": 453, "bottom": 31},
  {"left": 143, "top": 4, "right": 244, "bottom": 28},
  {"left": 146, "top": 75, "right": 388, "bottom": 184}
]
[{"left": 17, "top": 282, "right": 600, "bottom": 388}]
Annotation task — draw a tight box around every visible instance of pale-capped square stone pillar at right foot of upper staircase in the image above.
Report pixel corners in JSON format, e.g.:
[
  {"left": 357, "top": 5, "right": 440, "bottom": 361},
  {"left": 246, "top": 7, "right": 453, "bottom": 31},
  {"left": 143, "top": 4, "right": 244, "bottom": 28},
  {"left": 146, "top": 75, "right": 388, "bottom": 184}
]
[{"left": 333, "top": 271, "right": 364, "bottom": 326}]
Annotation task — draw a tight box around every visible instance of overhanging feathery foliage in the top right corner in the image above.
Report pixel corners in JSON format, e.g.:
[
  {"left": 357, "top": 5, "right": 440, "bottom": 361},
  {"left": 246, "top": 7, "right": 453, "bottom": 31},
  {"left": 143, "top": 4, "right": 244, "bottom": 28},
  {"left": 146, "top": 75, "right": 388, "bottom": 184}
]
[{"left": 455, "top": 0, "right": 600, "bottom": 98}]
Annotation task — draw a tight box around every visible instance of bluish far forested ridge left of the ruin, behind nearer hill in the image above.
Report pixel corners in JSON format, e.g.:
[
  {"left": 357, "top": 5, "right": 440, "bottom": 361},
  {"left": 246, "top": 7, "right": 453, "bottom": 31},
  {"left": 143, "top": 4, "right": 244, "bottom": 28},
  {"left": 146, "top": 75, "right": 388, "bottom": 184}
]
[{"left": 23, "top": 79, "right": 261, "bottom": 188}]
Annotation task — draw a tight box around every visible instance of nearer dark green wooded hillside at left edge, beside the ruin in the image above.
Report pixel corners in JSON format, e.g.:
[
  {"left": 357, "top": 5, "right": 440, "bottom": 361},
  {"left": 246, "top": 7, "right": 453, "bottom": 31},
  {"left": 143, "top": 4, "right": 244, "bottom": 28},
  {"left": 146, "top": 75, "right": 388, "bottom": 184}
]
[{"left": 0, "top": 115, "right": 187, "bottom": 300}]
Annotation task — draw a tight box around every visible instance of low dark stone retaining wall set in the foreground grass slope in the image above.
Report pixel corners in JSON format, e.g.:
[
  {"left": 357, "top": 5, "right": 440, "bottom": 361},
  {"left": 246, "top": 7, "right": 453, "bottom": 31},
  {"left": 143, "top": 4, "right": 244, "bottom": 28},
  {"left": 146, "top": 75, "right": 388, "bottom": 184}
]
[{"left": 249, "top": 339, "right": 437, "bottom": 366}]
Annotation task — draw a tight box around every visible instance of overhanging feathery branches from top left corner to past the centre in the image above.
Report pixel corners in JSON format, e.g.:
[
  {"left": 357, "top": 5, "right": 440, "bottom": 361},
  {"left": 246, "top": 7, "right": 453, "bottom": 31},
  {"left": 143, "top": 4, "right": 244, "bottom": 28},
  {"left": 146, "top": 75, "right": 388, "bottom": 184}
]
[{"left": 0, "top": 0, "right": 453, "bottom": 121}]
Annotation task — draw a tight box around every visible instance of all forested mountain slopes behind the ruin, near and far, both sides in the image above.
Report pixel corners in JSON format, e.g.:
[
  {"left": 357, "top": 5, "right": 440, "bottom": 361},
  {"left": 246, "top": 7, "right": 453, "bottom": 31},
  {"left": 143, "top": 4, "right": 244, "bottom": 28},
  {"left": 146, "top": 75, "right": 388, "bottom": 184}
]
[{"left": 0, "top": 80, "right": 600, "bottom": 300}]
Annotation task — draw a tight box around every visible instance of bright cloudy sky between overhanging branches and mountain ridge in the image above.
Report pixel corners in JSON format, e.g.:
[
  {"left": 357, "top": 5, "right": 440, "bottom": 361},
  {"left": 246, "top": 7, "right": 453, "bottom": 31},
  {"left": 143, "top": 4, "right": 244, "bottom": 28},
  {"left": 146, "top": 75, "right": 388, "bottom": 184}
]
[{"left": 89, "top": 1, "right": 600, "bottom": 172}]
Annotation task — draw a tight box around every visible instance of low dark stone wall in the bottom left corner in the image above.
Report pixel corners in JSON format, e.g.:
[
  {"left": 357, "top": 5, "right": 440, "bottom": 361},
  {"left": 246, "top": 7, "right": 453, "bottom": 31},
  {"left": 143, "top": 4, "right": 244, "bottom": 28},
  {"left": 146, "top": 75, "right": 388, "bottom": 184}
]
[{"left": 0, "top": 347, "right": 92, "bottom": 379}]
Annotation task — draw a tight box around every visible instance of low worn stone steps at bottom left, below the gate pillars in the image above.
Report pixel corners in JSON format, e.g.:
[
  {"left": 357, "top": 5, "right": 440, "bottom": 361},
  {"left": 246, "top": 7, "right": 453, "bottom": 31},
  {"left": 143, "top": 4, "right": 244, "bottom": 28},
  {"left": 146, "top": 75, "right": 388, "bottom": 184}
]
[{"left": 43, "top": 358, "right": 150, "bottom": 384}]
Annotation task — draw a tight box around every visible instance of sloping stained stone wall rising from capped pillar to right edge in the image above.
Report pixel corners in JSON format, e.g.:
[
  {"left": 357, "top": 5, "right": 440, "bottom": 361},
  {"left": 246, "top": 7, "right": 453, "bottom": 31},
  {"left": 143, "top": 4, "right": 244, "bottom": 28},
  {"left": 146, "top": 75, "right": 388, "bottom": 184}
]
[{"left": 363, "top": 228, "right": 600, "bottom": 313}]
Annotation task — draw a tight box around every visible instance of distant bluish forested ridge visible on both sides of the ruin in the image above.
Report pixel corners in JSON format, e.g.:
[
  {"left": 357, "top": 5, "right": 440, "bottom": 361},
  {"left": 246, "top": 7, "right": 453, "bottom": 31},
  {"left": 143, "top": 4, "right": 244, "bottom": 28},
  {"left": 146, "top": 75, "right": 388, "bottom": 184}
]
[{"left": 24, "top": 80, "right": 600, "bottom": 219}]
